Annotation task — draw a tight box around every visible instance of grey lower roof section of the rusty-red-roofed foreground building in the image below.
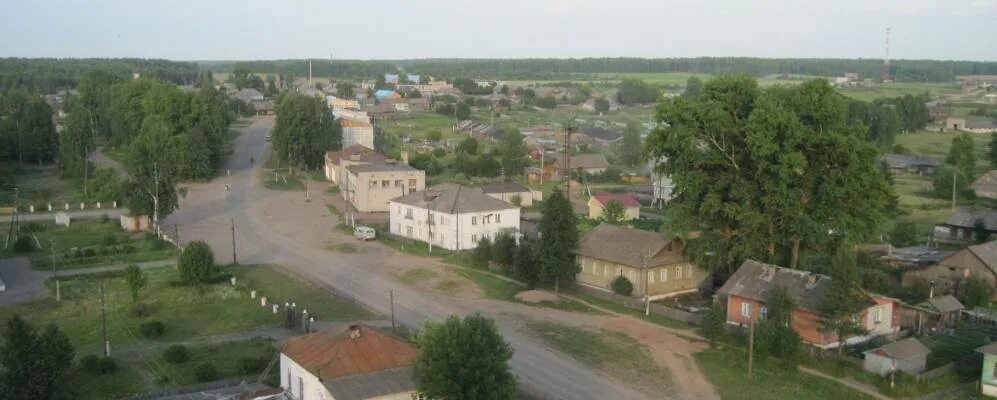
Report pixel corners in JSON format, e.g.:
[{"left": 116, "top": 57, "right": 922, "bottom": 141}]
[{"left": 323, "top": 367, "right": 415, "bottom": 400}]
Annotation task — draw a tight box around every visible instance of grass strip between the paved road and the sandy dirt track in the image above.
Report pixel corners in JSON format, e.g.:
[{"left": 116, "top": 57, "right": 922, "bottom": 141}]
[{"left": 526, "top": 320, "right": 671, "bottom": 394}]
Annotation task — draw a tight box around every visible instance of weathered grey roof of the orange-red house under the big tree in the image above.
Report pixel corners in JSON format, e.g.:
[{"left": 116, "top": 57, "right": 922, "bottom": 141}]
[{"left": 717, "top": 260, "right": 831, "bottom": 314}]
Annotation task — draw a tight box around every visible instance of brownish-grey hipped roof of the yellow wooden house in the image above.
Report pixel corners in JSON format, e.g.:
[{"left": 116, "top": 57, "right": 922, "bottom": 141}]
[{"left": 575, "top": 224, "right": 686, "bottom": 268}]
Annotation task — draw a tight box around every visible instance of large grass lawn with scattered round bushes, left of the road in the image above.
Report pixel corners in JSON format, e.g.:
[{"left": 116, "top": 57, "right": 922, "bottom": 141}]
[{"left": 0, "top": 265, "right": 374, "bottom": 399}]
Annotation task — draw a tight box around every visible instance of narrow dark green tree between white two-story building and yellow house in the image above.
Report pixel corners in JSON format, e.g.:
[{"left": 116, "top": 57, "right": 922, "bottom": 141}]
[{"left": 536, "top": 188, "right": 579, "bottom": 288}]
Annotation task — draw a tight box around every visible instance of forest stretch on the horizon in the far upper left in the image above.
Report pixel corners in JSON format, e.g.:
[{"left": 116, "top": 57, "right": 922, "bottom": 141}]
[{"left": 0, "top": 58, "right": 198, "bottom": 93}]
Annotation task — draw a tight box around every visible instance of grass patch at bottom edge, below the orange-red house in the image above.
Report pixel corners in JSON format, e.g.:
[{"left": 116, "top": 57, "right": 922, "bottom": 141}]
[{"left": 693, "top": 347, "right": 871, "bottom": 400}]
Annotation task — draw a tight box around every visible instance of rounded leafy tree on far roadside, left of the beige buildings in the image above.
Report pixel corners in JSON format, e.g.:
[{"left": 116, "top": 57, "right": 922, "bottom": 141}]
[{"left": 273, "top": 94, "right": 342, "bottom": 169}]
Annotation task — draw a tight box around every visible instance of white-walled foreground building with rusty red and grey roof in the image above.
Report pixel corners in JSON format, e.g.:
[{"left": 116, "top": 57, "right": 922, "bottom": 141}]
[{"left": 280, "top": 325, "right": 419, "bottom": 400}]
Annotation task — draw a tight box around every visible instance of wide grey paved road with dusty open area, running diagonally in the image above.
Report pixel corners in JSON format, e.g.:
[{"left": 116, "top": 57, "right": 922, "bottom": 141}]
[{"left": 164, "top": 119, "right": 644, "bottom": 400}]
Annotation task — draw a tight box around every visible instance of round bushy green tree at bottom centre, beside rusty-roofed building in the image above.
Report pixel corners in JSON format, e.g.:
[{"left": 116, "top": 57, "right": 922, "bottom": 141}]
[{"left": 413, "top": 314, "right": 516, "bottom": 400}]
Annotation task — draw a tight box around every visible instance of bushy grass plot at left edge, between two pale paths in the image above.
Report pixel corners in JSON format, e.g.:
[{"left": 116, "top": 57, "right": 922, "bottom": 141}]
[{"left": 0, "top": 219, "right": 177, "bottom": 270}]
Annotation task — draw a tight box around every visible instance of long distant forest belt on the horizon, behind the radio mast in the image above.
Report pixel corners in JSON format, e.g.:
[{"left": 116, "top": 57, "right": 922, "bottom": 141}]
[{"left": 201, "top": 57, "right": 997, "bottom": 82}]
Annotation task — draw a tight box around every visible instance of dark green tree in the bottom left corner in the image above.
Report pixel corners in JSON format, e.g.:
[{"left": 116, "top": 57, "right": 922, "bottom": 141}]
[{"left": 0, "top": 315, "right": 76, "bottom": 400}]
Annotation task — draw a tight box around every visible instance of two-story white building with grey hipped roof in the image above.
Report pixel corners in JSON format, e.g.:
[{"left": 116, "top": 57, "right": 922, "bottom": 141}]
[{"left": 389, "top": 183, "right": 519, "bottom": 250}]
